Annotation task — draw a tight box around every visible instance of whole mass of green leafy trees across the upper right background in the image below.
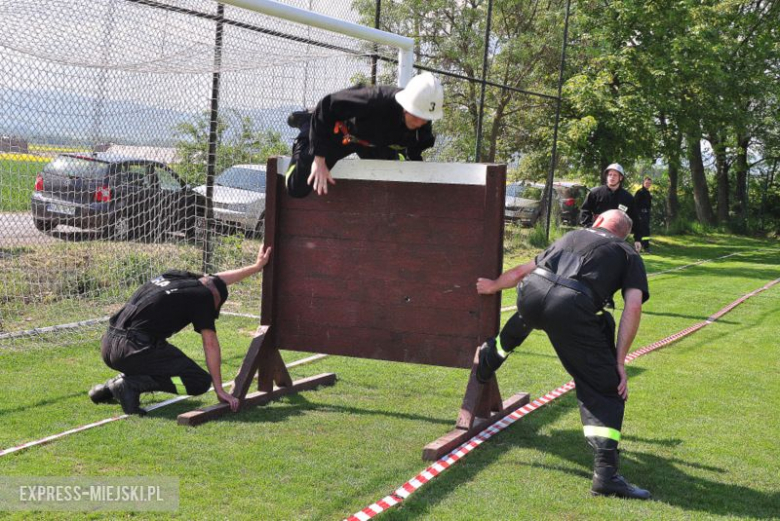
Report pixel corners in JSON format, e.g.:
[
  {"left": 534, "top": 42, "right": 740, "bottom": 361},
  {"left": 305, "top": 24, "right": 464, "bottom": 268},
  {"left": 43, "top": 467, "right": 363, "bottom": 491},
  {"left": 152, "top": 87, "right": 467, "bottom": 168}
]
[{"left": 354, "top": 0, "right": 780, "bottom": 232}]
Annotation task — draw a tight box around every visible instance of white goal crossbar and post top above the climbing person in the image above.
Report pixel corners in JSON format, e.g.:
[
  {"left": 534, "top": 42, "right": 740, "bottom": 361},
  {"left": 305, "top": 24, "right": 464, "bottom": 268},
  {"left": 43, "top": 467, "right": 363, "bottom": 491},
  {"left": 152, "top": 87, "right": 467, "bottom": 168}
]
[{"left": 222, "top": 0, "right": 414, "bottom": 87}]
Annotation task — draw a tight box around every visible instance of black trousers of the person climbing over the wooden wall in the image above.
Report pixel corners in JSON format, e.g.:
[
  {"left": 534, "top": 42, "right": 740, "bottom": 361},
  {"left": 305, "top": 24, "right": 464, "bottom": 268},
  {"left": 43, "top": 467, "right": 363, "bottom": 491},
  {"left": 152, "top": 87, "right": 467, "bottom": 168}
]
[{"left": 285, "top": 121, "right": 399, "bottom": 198}]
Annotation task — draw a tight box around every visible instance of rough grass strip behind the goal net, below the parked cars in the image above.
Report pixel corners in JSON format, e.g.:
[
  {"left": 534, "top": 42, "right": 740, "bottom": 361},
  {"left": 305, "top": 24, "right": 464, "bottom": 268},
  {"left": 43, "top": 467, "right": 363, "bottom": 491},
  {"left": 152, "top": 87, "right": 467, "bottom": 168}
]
[{"left": 0, "top": 237, "right": 261, "bottom": 334}]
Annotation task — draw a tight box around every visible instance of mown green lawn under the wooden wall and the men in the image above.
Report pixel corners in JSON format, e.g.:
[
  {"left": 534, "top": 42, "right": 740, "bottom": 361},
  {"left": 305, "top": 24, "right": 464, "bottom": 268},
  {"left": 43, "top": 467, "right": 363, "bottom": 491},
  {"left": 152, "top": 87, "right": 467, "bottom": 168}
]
[{"left": 0, "top": 235, "right": 780, "bottom": 521}]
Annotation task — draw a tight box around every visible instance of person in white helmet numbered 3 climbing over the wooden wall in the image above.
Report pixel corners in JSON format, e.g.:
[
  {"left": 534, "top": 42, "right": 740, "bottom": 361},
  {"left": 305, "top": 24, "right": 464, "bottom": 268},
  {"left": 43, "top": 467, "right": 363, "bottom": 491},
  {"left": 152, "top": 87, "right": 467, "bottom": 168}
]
[{"left": 285, "top": 72, "right": 444, "bottom": 197}]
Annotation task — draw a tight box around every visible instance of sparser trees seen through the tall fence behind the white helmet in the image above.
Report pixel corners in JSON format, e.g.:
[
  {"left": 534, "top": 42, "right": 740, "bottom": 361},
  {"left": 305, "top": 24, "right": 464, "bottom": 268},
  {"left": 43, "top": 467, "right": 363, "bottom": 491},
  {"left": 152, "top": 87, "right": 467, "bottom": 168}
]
[{"left": 353, "top": 0, "right": 565, "bottom": 165}]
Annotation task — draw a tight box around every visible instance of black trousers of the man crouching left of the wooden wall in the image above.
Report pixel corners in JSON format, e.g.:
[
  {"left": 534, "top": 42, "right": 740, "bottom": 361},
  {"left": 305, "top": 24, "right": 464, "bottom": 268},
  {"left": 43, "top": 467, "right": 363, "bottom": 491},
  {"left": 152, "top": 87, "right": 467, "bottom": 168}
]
[{"left": 101, "top": 327, "right": 211, "bottom": 396}]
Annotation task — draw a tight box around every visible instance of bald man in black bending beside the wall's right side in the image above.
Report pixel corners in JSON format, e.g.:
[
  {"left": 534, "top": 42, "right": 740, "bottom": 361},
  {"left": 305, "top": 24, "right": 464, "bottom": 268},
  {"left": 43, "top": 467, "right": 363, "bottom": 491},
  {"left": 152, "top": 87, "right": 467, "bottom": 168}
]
[{"left": 477, "top": 210, "right": 650, "bottom": 499}]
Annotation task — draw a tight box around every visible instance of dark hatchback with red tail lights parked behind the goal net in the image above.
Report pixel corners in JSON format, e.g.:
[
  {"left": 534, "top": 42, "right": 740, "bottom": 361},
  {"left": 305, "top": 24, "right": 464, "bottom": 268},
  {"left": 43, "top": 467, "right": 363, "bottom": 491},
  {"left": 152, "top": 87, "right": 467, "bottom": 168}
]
[{"left": 32, "top": 153, "right": 205, "bottom": 240}]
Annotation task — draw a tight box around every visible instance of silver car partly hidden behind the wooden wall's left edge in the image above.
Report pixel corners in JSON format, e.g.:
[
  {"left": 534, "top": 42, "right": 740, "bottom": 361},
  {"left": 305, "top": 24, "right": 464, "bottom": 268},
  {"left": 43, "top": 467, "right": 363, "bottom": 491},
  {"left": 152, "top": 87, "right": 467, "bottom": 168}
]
[{"left": 195, "top": 165, "right": 266, "bottom": 236}]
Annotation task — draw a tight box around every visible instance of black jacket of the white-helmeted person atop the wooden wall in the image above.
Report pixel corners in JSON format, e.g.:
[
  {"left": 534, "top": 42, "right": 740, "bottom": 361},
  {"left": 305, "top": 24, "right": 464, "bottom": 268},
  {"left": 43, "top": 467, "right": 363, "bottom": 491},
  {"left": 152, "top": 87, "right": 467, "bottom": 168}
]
[{"left": 309, "top": 86, "right": 435, "bottom": 161}]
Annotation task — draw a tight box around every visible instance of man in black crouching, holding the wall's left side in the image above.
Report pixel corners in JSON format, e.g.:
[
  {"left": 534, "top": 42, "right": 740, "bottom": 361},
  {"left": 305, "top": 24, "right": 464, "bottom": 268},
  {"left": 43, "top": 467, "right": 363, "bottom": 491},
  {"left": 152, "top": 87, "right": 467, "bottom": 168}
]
[{"left": 89, "top": 245, "right": 271, "bottom": 414}]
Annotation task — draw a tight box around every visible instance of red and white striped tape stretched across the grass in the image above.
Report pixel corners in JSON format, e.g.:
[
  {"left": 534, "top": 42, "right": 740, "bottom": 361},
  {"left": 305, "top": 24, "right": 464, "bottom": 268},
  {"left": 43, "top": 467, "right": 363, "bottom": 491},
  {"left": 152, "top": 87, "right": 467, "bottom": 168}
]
[{"left": 346, "top": 279, "right": 780, "bottom": 521}]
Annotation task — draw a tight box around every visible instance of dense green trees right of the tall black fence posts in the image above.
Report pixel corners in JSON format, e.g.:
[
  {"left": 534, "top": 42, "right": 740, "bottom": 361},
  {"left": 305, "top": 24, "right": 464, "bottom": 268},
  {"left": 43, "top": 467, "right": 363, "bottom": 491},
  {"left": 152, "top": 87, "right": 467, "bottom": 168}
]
[{"left": 567, "top": 0, "right": 778, "bottom": 228}]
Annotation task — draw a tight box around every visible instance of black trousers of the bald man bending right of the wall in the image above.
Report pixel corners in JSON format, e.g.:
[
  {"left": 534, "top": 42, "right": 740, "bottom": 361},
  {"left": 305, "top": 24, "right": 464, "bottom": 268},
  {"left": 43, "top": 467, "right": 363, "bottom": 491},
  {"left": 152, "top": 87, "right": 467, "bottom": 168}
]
[{"left": 500, "top": 273, "right": 625, "bottom": 448}]
